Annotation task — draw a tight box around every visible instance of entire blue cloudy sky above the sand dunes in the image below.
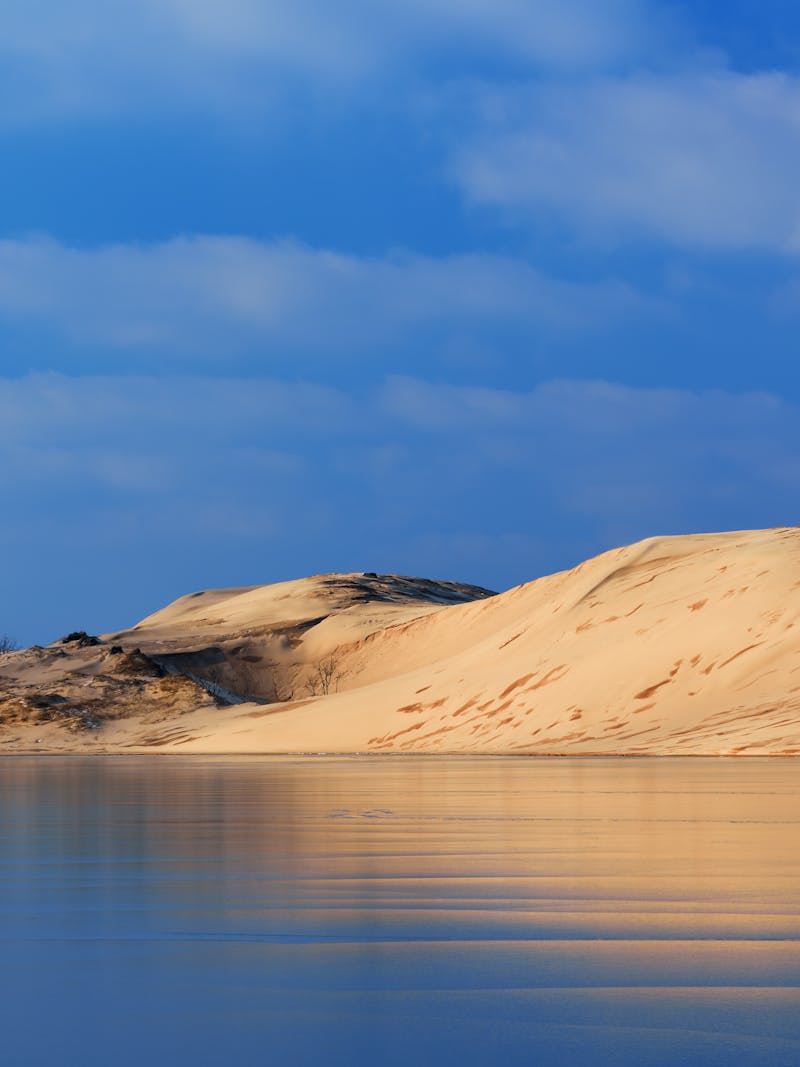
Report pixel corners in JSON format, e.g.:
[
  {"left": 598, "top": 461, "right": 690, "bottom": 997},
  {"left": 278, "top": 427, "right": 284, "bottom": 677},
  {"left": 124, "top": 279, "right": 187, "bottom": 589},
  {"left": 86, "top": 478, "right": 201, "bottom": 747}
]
[{"left": 0, "top": 0, "right": 800, "bottom": 644}]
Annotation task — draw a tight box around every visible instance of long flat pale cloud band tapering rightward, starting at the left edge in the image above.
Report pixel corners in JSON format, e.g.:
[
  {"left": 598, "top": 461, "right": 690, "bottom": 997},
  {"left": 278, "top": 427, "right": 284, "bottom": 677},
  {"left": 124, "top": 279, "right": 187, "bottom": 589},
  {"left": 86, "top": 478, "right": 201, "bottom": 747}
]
[{"left": 0, "top": 236, "right": 655, "bottom": 362}]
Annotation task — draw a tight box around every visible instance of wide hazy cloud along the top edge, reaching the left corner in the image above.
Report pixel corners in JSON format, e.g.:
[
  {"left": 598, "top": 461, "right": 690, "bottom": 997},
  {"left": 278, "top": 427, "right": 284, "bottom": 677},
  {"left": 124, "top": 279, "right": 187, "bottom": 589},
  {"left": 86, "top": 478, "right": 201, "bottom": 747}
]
[{"left": 0, "top": 0, "right": 653, "bottom": 123}]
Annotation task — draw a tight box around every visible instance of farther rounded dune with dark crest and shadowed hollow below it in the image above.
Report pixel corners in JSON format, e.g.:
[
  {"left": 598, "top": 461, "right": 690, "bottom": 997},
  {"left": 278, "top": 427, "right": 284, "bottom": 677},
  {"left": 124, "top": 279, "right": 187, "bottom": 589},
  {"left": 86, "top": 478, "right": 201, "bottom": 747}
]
[{"left": 120, "top": 573, "right": 495, "bottom": 703}]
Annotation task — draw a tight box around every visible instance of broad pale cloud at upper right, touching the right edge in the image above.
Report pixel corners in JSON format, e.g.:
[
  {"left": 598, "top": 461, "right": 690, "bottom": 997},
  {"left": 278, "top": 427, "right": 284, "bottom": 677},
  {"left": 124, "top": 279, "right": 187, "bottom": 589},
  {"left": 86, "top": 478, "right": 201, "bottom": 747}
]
[{"left": 453, "top": 70, "right": 800, "bottom": 253}]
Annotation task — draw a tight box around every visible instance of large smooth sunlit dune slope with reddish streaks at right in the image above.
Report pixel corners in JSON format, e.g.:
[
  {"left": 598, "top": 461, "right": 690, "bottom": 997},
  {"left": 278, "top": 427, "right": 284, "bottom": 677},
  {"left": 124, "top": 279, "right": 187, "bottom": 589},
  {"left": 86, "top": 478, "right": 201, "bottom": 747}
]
[{"left": 177, "top": 528, "right": 800, "bottom": 755}]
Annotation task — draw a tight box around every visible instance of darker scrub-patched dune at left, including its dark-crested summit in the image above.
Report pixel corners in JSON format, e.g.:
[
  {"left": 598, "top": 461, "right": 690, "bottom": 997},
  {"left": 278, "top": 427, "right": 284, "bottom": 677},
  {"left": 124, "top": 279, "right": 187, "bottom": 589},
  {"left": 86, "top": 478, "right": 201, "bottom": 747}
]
[{"left": 0, "top": 573, "right": 494, "bottom": 751}]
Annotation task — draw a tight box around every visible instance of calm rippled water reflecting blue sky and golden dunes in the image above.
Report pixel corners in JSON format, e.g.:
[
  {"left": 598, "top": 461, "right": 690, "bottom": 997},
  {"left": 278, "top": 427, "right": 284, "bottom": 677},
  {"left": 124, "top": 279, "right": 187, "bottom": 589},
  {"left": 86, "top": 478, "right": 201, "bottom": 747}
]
[{"left": 0, "top": 757, "right": 800, "bottom": 1067}]
